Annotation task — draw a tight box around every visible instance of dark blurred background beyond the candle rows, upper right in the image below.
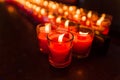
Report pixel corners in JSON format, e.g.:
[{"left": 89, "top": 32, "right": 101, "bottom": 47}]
[{"left": 53, "top": 0, "right": 120, "bottom": 36}]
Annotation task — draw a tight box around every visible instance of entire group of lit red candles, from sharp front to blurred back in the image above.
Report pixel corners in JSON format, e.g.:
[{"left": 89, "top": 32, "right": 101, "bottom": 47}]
[{"left": 6, "top": 0, "right": 111, "bottom": 68}]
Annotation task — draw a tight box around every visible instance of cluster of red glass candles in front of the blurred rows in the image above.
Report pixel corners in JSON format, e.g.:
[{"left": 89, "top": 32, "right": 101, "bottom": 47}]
[{"left": 36, "top": 23, "right": 94, "bottom": 68}]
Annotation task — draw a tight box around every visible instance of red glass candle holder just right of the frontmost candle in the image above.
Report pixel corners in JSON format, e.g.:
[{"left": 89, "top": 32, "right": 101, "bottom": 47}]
[{"left": 73, "top": 27, "right": 94, "bottom": 58}]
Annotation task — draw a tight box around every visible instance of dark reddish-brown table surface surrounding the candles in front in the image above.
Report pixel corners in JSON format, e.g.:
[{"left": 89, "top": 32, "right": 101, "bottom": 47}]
[{"left": 0, "top": 3, "right": 120, "bottom": 80}]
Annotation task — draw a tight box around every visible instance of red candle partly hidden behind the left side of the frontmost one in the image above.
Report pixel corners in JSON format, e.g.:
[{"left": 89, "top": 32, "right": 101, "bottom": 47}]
[{"left": 37, "top": 23, "right": 51, "bottom": 54}]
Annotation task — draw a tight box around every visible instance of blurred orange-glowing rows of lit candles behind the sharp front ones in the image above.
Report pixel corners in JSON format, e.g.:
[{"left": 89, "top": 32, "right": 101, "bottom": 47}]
[{"left": 11, "top": 0, "right": 112, "bottom": 35}]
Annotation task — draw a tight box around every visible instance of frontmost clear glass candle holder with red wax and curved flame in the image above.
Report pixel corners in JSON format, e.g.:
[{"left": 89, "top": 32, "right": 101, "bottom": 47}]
[{"left": 47, "top": 30, "right": 74, "bottom": 68}]
